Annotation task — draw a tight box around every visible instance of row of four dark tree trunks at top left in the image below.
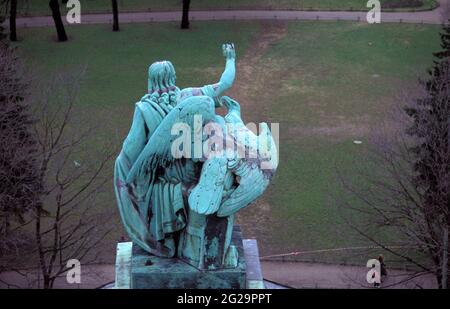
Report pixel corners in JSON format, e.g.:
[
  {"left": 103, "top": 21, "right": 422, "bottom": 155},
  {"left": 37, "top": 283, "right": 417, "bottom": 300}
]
[{"left": 0, "top": 0, "right": 191, "bottom": 42}]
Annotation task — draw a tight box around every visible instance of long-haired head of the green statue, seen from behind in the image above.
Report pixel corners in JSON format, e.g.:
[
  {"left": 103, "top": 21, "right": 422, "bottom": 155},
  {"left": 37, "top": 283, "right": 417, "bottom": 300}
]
[{"left": 148, "top": 60, "right": 176, "bottom": 93}]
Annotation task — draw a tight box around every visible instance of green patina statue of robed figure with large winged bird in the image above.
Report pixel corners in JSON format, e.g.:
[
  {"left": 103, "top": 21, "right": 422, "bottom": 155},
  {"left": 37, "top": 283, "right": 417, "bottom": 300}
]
[{"left": 114, "top": 44, "right": 278, "bottom": 270}]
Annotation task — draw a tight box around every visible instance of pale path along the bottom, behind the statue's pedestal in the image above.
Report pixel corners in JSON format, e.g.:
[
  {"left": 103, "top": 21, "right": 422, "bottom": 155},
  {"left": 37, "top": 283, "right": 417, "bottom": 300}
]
[{"left": 0, "top": 261, "right": 437, "bottom": 289}]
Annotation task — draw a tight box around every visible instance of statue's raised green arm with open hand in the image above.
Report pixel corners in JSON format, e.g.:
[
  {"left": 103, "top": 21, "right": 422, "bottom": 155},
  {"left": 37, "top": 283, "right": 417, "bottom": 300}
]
[{"left": 180, "top": 43, "right": 236, "bottom": 107}]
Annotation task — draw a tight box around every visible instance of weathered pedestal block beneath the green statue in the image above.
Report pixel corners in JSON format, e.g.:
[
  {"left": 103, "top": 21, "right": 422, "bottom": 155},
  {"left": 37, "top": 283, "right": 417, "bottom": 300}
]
[{"left": 115, "top": 229, "right": 264, "bottom": 289}]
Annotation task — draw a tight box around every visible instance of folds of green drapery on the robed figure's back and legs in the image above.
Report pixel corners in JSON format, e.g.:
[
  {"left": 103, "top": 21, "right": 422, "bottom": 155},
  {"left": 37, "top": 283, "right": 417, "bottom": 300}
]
[{"left": 114, "top": 97, "right": 186, "bottom": 257}]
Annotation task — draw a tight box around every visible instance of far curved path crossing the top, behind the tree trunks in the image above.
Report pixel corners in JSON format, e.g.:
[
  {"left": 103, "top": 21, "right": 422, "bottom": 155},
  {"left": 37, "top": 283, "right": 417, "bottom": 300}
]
[{"left": 5, "top": 0, "right": 450, "bottom": 28}]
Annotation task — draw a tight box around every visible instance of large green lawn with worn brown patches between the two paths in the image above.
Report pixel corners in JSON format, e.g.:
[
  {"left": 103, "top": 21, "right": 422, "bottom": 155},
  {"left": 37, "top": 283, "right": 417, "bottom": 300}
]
[{"left": 13, "top": 22, "right": 439, "bottom": 262}]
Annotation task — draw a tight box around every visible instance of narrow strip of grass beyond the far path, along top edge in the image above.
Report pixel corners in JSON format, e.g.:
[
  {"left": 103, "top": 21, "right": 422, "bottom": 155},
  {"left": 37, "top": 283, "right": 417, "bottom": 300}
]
[{"left": 22, "top": 0, "right": 437, "bottom": 15}]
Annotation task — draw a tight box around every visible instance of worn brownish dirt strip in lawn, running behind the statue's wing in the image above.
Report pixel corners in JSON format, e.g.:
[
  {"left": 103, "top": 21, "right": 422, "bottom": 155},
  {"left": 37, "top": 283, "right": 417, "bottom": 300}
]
[{"left": 230, "top": 22, "right": 287, "bottom": 252}]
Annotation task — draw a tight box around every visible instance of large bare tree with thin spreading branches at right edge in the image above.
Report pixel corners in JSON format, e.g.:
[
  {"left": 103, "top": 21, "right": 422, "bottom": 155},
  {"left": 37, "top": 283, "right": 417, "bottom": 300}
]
[{"left": 339, "top": 58, "right": 450, "bottom": 288}]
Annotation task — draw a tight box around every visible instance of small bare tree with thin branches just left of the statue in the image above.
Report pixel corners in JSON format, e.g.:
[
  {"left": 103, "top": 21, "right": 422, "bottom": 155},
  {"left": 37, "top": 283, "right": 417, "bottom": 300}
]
[{"left": 28, "top": 69, "right": 112, "bottom": 288}]
